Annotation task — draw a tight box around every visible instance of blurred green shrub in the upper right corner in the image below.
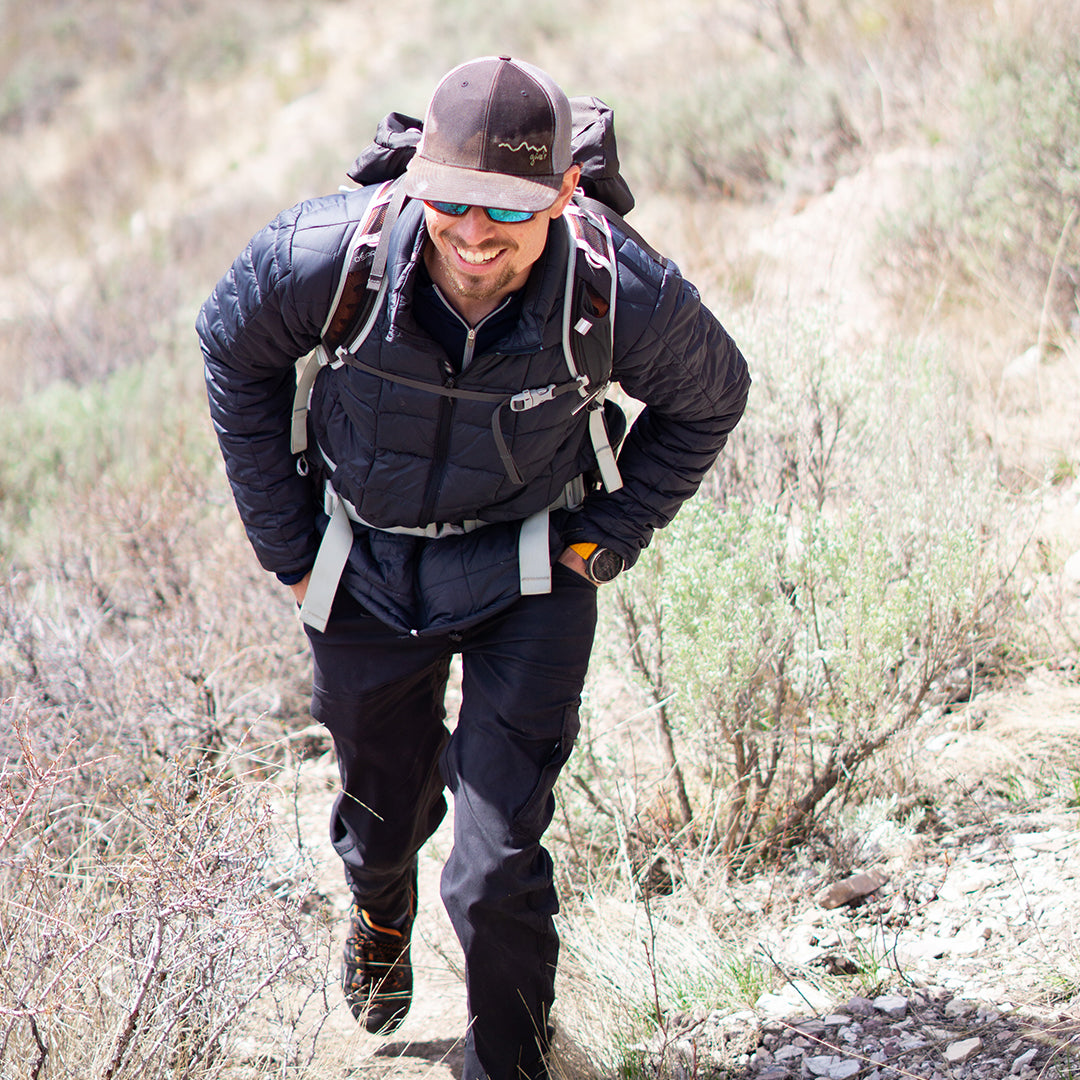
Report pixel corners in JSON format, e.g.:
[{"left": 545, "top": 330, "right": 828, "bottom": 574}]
[{"left": 881, "top": 5, "right": 1080, "bottom": 333}]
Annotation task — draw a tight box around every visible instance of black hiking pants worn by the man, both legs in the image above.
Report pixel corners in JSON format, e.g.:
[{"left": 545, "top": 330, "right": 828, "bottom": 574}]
[{"left": 308, "top": 564, "right": 596, "bottom": 1080}]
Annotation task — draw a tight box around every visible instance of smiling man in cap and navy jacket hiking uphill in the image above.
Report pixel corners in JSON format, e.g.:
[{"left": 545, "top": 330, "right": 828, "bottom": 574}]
[{"left": 199, "top": 57, "right": 750, "bottom": 1080}]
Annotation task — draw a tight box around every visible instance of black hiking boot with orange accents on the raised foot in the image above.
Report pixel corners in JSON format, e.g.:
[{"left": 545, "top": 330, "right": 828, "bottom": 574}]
[{"left": 341, "top": 904, "right": 413, "bottom": 1035}]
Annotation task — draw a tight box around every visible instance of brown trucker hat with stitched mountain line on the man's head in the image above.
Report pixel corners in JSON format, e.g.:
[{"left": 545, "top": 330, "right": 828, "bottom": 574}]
[{"left": 405, "top": 56, "right": 573, "bottom": 212}]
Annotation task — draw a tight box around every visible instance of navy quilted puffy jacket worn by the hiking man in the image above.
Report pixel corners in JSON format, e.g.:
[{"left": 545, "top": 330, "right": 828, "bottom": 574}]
[{"left": 198, "top": 188, "right": 750, "bottom": 633}]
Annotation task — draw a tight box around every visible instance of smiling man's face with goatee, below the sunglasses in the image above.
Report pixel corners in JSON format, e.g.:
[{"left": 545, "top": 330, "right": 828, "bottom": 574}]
[{"left": 424, "top": 165, "right": 581, "bottom": 323}]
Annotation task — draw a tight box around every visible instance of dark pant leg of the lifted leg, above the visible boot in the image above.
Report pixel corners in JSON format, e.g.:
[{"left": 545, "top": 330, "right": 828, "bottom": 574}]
[{"left": 308, "top": 592, "right": 450, "bottom": 920}]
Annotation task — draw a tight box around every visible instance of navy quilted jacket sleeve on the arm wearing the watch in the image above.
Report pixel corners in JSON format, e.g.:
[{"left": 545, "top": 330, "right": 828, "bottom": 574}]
[{"left": 564, "top": 241, "right": 751, "bottom": 566}]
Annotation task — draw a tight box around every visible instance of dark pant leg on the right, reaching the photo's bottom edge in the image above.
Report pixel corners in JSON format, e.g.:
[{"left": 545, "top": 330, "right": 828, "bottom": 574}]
[{"left": 442, "top": 565, "right": 596, "bottom": 1080}]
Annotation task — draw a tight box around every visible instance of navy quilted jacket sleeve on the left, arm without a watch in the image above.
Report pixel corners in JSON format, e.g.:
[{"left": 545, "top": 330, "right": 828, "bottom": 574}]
[{"left": 197, "top": 197, "right": 356, "bottom": 580}]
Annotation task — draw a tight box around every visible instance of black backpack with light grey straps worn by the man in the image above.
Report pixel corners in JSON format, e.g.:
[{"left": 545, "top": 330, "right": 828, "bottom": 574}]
[{"left": 291, "top": 97, "right": 663, "bottom": 631}]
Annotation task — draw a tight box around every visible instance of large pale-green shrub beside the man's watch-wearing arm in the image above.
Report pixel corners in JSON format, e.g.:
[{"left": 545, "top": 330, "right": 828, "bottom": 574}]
[{"left": 587, "top": 311, "right": 1002, "bottom": 866}]
